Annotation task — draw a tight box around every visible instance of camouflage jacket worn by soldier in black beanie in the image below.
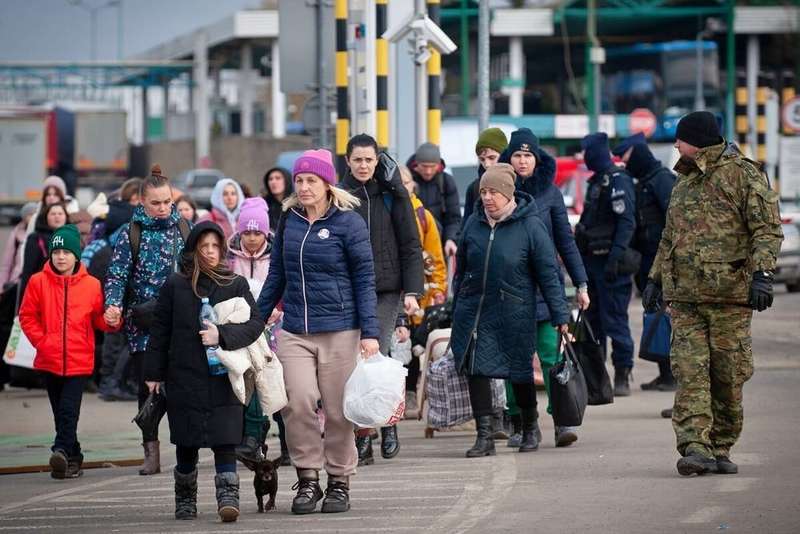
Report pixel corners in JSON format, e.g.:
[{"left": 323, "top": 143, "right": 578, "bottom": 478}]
[{"left": 649, "top": 142, "right": 783, "bottom": 304}]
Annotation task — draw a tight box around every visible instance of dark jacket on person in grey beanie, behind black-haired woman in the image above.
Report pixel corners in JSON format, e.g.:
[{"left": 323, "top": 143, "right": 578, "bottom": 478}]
[{"left": 406, "top": 156, "right": 461, "bottom": 245}]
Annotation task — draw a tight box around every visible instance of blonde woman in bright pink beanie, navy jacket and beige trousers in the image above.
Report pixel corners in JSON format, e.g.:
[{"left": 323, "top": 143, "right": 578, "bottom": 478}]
[{"left": 258, "top": 149, "right": 378, "bottom": 514}]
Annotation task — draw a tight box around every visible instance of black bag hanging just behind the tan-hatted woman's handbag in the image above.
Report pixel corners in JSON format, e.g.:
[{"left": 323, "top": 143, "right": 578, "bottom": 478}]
[{"left": 573, "top": 310, "right": 614, "bottom": 406}]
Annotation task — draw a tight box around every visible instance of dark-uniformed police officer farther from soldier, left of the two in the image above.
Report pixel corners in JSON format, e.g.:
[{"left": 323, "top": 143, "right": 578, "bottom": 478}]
[{"left": 575, "top": 132, "right": 639, "bottom": 397}]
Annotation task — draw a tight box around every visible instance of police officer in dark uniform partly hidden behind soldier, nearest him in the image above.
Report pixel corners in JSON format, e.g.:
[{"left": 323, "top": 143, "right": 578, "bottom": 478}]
[{"left": 613, "top": 133, "right": 676, "bottom": 391}]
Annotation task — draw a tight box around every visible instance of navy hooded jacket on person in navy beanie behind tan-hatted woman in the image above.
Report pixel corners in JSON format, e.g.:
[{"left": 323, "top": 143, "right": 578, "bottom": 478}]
[{"left": 499, "top": 149, "right": 588, "bottom": 321}]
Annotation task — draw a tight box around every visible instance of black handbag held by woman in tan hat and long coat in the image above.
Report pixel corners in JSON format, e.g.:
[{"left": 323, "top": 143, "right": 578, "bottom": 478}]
[{"left": 550, "top": 335, "right": 588, "bottom": 426}]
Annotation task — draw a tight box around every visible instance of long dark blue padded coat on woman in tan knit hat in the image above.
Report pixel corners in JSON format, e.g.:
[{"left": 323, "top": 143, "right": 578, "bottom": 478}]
[{"left": 450, "top": 191, "right": 569, "bottom": 383}]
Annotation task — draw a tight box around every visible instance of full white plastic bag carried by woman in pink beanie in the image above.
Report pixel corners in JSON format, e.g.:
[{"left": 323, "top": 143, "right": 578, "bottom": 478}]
[{"left": 344, "top": 354, "right": 408, "bottom": 428}]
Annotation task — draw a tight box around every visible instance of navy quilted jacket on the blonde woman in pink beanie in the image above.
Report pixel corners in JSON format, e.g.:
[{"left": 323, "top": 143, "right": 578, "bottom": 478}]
[{"left": 258, "top": 206, "right": 378, "bottom": 339}]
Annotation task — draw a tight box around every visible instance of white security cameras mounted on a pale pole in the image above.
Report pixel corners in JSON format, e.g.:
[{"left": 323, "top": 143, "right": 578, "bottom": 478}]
[{"left": 383, "top": 0, "right": 458, "bottom": 145}]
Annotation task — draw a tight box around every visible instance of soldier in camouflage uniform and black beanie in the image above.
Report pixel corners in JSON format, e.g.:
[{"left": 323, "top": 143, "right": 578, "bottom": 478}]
[{"left": 643, "top": 111, "right": 783, "bottom": 475}]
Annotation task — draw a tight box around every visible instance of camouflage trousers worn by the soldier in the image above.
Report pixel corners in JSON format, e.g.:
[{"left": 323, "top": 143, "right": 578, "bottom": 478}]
[{"left": 670, "top": 302, "right": 753, "bottom": 457}]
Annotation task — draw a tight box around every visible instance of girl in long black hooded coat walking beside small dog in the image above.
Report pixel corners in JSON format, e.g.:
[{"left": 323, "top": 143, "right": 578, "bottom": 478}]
[{"left": 145, "top": 222, "right": 264, "bottom": 521}]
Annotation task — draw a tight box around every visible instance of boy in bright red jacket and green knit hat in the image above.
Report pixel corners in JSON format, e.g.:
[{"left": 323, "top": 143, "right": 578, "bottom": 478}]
[{"left": 19, "top": 224, "right": 122, "bottom": 479}]
